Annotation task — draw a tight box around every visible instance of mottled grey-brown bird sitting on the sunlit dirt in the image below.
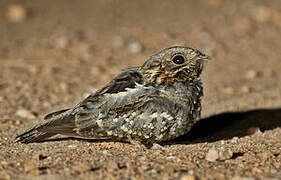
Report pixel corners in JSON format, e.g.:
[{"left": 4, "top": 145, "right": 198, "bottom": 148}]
[{"left": 15, "top": 46, "right": 211, "bottom": 147}]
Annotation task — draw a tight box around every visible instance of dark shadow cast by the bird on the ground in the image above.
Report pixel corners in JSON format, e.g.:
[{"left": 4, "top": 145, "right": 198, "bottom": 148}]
[{"left": 41, "top": 108, "right": 281, "bottom": 144}]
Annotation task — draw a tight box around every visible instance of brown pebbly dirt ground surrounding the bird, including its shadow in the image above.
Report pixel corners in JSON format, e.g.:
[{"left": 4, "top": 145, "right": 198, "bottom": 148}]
[{"left": 0, "top": 0, "right": 281, "bottom": 180}]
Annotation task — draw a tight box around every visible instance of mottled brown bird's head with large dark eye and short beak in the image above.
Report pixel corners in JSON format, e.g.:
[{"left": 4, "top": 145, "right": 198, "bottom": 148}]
[{"left": 140, "top": 46, "right": 211, "bottom": 84}]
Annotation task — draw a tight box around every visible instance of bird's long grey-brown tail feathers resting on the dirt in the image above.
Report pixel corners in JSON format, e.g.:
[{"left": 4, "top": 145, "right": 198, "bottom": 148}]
[{"left": 15, "top": 109, "right": 75, "bottom": 143}]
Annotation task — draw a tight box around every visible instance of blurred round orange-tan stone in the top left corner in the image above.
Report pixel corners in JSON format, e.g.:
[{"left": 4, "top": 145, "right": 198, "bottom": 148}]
[{"left": 6, "top": 4, "right": 26, "bottom": 23}]
